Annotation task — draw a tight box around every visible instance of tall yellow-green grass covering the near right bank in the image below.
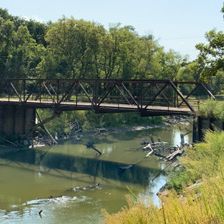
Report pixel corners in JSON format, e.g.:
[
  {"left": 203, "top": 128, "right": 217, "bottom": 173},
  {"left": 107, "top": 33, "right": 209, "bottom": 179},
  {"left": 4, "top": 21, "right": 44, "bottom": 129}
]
[{"left": 105, "top": 132, "right": 224, "bottom": 224}]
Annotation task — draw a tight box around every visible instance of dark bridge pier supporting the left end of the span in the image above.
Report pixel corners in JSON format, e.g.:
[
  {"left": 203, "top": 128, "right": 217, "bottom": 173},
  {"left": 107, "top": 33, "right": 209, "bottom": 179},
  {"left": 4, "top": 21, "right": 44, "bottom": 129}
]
[{"left": 0, "top": 105, "right": 36, "bottom": 139}]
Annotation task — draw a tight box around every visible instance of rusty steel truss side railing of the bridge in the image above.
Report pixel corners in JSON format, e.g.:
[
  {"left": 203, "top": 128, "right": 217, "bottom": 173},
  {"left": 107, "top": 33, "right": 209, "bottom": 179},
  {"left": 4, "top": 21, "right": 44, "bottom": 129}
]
[{"left": 0, "top": 79, "right": 214, "bottom": 112}]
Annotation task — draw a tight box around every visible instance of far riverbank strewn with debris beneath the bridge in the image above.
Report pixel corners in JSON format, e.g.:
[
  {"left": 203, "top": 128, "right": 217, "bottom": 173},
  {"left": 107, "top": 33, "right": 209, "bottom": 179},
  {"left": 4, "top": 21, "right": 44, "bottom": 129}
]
[{"left": 33, "top": 116, "right": 191, "bottom": 148}]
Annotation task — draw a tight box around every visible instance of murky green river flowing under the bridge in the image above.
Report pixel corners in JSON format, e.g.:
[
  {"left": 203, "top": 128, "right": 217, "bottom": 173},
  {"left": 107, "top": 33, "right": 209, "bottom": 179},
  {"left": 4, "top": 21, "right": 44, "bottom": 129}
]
[{"left": 0, "top": 122, "right": 192, "bottom": 224}]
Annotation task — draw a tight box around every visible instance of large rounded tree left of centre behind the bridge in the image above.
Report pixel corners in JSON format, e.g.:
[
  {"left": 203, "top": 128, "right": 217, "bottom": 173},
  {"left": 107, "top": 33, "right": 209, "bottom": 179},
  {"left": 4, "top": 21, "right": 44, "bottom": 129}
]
[{"left": 39, "top": 18, "right": 105, "bottom": 78}]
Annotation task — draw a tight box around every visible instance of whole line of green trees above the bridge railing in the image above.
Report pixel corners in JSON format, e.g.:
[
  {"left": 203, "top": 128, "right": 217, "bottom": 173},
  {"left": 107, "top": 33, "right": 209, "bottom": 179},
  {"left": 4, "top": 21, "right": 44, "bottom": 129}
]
[{"left": 0, "top": 9, "right": 224, "bottom": 83}]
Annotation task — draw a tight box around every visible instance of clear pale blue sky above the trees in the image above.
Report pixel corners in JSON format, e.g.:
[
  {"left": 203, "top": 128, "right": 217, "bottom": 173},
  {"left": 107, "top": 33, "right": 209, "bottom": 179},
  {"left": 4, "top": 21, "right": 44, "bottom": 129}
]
[{"left": 0, "top": 0, "right": 224, "bottom": 59}]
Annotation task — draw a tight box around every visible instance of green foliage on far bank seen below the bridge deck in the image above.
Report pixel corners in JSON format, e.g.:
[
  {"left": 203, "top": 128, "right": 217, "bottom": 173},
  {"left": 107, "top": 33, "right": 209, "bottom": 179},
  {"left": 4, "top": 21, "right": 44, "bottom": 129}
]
[{"left": 38, "top": 110, "right": 162, "bottom": 136}]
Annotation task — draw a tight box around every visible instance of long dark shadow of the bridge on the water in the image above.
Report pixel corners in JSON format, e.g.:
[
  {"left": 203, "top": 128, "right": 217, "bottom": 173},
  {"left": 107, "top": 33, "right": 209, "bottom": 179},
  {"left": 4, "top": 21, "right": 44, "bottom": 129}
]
[{"left": 1, "top": 149, "right": 160, "bottom": 186}]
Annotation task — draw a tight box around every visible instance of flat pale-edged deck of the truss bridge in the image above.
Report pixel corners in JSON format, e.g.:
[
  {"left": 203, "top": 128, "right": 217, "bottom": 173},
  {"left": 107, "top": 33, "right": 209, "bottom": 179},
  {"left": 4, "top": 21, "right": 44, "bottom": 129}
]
[{"left": 0, "top": 98, "right": 192, "bottom": 116}]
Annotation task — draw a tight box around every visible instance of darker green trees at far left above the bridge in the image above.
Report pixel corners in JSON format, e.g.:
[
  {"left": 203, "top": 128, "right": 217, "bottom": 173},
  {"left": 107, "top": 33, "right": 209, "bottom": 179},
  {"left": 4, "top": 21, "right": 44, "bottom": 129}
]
[{"left": 0, "top": 10, "right": 45, "bottom": 78}]
